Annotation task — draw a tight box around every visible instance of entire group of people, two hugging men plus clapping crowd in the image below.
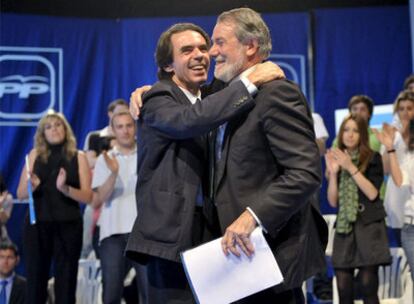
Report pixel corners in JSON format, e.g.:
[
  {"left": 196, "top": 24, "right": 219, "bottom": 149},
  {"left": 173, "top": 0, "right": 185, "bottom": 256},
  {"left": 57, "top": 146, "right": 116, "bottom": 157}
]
[{"left": 0, "top": 8, "right": 414, "bottom": 304}]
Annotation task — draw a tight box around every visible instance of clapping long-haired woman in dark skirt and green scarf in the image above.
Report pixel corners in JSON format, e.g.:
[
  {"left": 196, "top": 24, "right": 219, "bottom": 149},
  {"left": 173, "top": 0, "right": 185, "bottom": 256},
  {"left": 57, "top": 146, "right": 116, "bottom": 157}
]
[{"left": 326, "top": 116, "right": 391, "bottom": 304}]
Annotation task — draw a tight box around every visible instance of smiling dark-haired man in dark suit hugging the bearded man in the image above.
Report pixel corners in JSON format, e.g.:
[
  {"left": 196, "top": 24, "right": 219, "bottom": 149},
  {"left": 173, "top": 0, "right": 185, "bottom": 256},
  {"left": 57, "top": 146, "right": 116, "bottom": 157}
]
[{"left": 126, "top": 23, "right": 279, "bottom": 304}]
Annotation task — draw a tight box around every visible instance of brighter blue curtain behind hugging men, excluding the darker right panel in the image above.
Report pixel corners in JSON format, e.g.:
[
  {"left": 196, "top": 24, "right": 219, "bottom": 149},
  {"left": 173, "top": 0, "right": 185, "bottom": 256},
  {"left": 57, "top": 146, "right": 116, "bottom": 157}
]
[{"left": 0, "top": 13, "right": 309, "bottom": 274}]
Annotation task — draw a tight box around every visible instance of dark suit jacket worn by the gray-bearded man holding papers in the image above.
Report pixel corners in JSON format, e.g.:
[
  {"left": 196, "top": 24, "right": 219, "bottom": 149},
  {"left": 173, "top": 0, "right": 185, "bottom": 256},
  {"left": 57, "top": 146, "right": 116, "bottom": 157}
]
[{"left": 214, "top": 80, "right": 327, "bottom": 290}]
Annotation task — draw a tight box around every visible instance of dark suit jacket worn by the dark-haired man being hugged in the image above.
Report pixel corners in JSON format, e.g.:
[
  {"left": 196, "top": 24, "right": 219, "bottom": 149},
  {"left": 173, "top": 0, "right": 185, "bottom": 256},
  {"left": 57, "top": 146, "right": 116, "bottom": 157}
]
[{"left": 126, "top": 81, "right": 254, "bottom": 261}]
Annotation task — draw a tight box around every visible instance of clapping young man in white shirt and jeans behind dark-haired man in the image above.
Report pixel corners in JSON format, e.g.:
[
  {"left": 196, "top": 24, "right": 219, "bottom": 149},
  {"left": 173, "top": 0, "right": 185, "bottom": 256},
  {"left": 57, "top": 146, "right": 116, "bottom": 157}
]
[{"left": 92, "top": 111, "right": 139, "bottom": 304}]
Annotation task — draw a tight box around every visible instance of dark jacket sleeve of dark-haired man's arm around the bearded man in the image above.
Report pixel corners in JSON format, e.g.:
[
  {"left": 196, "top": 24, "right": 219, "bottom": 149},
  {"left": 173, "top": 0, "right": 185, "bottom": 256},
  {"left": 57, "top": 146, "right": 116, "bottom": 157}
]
[{"left": 141, "top": 81, "right": 254, "bottom": 139}]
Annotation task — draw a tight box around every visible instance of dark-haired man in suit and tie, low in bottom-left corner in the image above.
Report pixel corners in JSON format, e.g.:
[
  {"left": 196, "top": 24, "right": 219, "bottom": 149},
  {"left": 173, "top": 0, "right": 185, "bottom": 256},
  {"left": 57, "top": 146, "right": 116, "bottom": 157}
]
[{"left": 0, "top": 242, "right": 26, "bottom": 304}]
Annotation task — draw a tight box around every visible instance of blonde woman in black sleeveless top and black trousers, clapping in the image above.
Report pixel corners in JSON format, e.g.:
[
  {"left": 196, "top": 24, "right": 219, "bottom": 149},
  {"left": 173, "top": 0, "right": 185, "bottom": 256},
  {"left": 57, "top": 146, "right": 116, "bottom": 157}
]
[{"left": 17, "top": 113, "right": 92, "bottom": 304}]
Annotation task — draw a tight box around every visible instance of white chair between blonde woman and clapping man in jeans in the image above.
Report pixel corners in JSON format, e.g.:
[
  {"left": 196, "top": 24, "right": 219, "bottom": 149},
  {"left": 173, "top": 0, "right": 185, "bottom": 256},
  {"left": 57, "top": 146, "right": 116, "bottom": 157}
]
[{"left": 76, "top": 259, "right": 102, "bottom": 304}]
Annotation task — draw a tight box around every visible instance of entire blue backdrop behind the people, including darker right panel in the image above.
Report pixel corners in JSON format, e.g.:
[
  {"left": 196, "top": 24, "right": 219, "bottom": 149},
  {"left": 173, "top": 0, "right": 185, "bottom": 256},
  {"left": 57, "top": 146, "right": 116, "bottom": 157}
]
[{"left": 0, "top": 6, "right": 412, "bottom": 272}]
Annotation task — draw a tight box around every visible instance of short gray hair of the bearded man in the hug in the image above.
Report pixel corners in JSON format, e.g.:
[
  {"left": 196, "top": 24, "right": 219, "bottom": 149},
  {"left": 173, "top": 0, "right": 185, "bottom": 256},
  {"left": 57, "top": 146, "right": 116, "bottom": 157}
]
[{"left": 217, "top": 7, "right": 272, "bottom": 59}]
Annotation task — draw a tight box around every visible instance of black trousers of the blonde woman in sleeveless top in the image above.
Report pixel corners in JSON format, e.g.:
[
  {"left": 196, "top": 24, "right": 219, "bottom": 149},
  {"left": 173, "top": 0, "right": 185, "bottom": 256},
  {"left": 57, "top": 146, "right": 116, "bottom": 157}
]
[{"left": 23, "top": 218, "right": 83, "bottom": 304}]
